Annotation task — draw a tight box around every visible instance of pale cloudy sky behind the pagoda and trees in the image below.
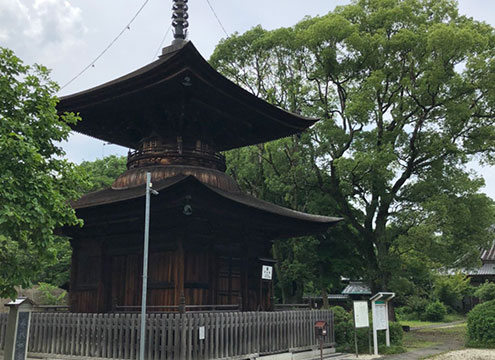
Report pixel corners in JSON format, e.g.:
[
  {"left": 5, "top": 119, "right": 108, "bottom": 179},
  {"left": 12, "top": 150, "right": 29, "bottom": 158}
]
[{"left": 0, "top": 0, "right": 495, "bottom": 199}]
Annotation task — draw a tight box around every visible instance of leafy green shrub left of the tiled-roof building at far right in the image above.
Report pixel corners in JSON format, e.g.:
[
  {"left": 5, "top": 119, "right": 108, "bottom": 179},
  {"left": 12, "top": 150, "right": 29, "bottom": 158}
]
[{"left": 433, "top": 273, "right": 472, "bottom": 309}]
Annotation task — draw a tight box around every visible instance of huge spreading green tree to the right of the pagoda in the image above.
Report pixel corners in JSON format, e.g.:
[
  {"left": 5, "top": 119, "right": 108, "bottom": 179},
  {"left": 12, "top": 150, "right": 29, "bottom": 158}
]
[{"left": 210, "top": 0, "right": 495, "bottom": 296}]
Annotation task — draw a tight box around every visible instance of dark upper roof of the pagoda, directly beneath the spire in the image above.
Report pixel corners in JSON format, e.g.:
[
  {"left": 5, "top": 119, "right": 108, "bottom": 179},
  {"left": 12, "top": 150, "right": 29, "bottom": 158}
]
[{"left": 57, "top": 42, "right": 317, "bottom": 151}]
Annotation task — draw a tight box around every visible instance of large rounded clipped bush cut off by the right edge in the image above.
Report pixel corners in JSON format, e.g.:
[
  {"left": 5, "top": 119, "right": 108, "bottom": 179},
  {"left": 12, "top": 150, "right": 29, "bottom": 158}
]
[{"left": 467, "top": 300, "right": 495, "bottom": 347}]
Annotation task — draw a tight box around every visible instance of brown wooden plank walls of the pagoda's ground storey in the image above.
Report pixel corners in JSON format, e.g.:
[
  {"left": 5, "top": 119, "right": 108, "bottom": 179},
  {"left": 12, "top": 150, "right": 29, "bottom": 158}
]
[{"left": 70, "top": 236, "right": 271, "bottom": 312}]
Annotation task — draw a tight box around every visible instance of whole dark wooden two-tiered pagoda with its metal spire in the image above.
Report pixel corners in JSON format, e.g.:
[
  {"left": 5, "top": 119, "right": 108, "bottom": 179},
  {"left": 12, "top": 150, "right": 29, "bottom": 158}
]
[{"left": 58, "top": 1, "right": 340, "bottom": 312}]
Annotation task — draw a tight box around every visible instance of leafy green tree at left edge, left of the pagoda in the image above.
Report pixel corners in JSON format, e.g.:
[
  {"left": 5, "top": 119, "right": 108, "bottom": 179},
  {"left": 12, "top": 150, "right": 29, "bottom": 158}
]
[{"left": 0, "top": 48, "right": 84, "bottom": 298}]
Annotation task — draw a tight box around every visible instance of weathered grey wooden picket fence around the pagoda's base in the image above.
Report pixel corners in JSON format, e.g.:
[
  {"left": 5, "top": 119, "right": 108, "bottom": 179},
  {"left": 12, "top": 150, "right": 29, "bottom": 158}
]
[{"left": 0, "top": 310, "right": 334, "bottom": 360}]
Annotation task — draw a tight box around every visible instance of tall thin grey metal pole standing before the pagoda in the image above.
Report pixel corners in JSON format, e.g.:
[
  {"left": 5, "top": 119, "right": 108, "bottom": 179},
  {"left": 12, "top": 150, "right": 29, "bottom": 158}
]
[{"left": 139, "top": 172, "right": 151, "bottom": 360}]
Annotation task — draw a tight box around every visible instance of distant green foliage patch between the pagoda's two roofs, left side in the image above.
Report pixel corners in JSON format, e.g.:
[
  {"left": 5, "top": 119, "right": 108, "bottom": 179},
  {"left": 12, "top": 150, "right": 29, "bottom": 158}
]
[{"left": 79, "top": 155, "right": 127, "bottom": 192}]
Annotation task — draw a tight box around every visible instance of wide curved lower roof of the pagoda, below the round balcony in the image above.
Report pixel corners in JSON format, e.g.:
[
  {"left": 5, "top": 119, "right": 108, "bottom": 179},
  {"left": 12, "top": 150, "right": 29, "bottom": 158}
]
[{"left": 72, "top": 174, "right": 342, "bottom": 240}]
